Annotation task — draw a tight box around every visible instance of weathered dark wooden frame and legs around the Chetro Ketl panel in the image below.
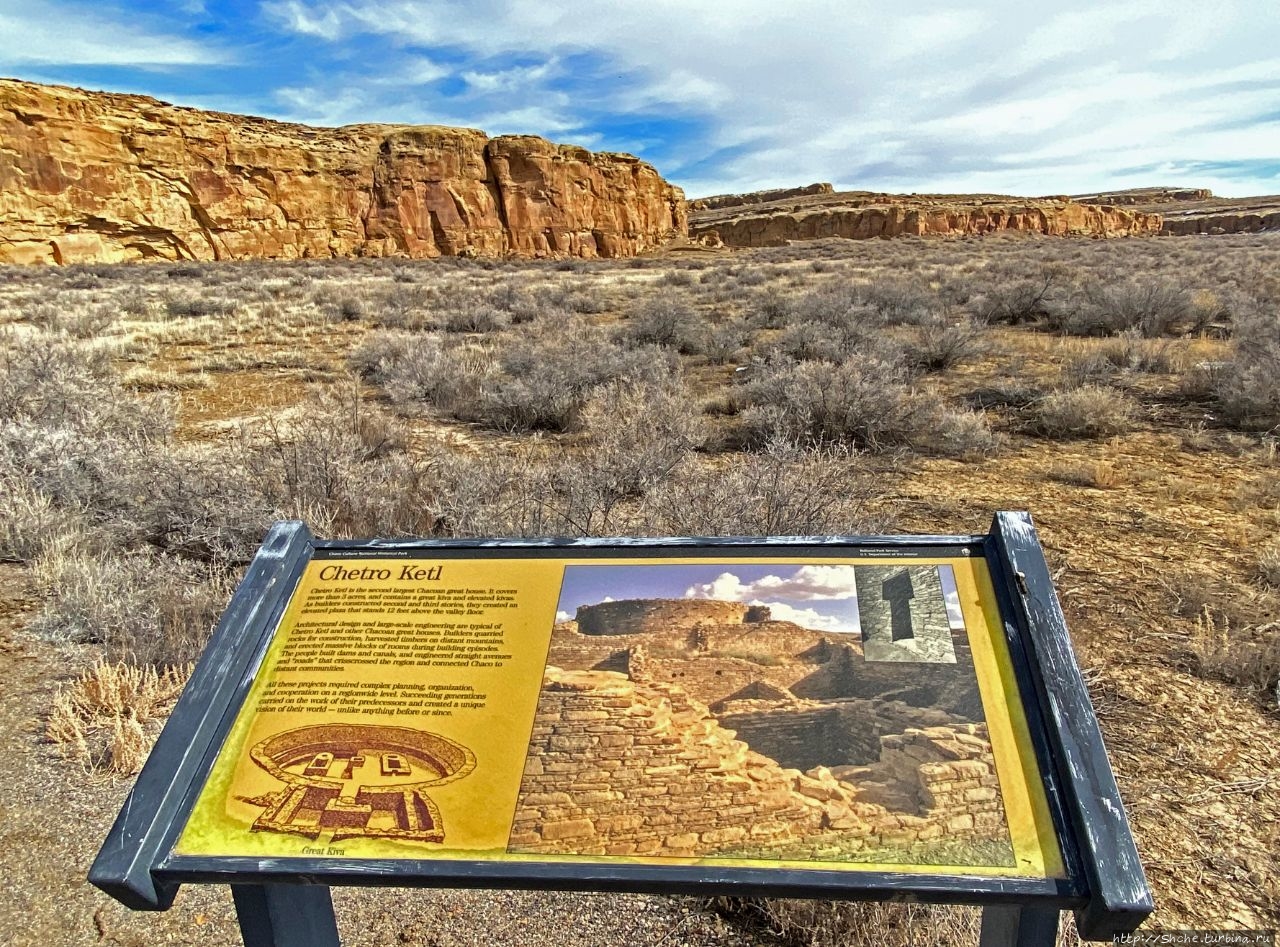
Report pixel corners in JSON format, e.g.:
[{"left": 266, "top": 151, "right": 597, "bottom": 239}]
[{"left": 90, "top": 512, "right": 1152, "bottom": 947}]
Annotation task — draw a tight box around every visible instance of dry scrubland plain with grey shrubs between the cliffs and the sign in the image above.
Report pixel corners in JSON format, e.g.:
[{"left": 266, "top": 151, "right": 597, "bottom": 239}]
[{"left": 0, "top": 234, "right": 1280, "bottom": 943}]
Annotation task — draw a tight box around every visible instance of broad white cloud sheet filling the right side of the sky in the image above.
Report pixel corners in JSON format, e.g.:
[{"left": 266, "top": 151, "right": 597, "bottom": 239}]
[{"left": 259, "top": 0, "right": 1280, "bottom": 196}]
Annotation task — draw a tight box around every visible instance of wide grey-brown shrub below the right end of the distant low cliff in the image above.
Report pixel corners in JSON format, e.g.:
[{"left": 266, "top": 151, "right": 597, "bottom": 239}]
[{"left": 1047, "top": 278, "right": 1196, "bottom": 338}]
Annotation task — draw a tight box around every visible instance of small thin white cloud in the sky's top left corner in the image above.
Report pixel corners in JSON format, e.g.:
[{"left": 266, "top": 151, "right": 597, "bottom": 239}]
[{"left": 0, "top": 0, "right": 229, "bottom": 68}]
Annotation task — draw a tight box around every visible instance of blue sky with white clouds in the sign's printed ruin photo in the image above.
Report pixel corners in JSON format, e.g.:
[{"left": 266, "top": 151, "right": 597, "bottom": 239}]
[{"left": 556, "top": 563, "right": 964, "bottom": 633}]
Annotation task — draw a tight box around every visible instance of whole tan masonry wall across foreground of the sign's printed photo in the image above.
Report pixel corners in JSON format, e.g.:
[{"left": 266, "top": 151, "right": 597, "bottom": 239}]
[{"left": 509, "top": 667, "right": 1004, "bottom": 859}]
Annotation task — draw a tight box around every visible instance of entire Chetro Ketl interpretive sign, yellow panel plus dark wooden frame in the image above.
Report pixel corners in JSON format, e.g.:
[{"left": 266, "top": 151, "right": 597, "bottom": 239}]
[{"left": 91, "top": 514, "right": 1151, "bottom": 943}]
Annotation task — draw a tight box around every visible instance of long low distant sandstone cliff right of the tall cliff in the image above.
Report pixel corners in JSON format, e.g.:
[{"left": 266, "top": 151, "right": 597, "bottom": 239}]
[{"left": 690, "top": 193, "right": 1161, "bottom": 247}]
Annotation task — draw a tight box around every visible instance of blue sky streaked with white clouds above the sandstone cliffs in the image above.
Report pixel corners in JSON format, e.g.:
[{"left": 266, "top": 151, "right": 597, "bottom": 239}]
[{"left": 0, "top": 0, "right": 1280, "bottom": 197}]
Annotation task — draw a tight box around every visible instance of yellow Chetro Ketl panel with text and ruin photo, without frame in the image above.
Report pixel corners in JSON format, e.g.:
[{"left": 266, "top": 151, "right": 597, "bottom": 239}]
[{"left": 173, "top": 545, "right": 1066, "bottom": 879}]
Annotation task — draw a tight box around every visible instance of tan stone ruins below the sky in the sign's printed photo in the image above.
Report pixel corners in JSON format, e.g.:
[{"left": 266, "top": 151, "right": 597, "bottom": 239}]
[{"left": 509, "top": 588, "right": 1012, "bottom": 865}]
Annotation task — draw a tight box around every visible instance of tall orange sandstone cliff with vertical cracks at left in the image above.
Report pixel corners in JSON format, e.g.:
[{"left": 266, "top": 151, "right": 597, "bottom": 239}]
[{"left": 0, "top": 79, "right": 687, "bottom": 264}]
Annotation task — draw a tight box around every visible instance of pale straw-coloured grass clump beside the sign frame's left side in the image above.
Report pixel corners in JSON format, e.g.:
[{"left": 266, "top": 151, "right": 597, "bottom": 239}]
[{"left": 45, "top": 660, "right": 193, "bottom": 776}]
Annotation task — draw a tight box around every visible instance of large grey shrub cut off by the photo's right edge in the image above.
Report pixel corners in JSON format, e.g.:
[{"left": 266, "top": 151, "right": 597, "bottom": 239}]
[{"left": 1208, "top": 303, "right": 1280, "bottom": 430}]
